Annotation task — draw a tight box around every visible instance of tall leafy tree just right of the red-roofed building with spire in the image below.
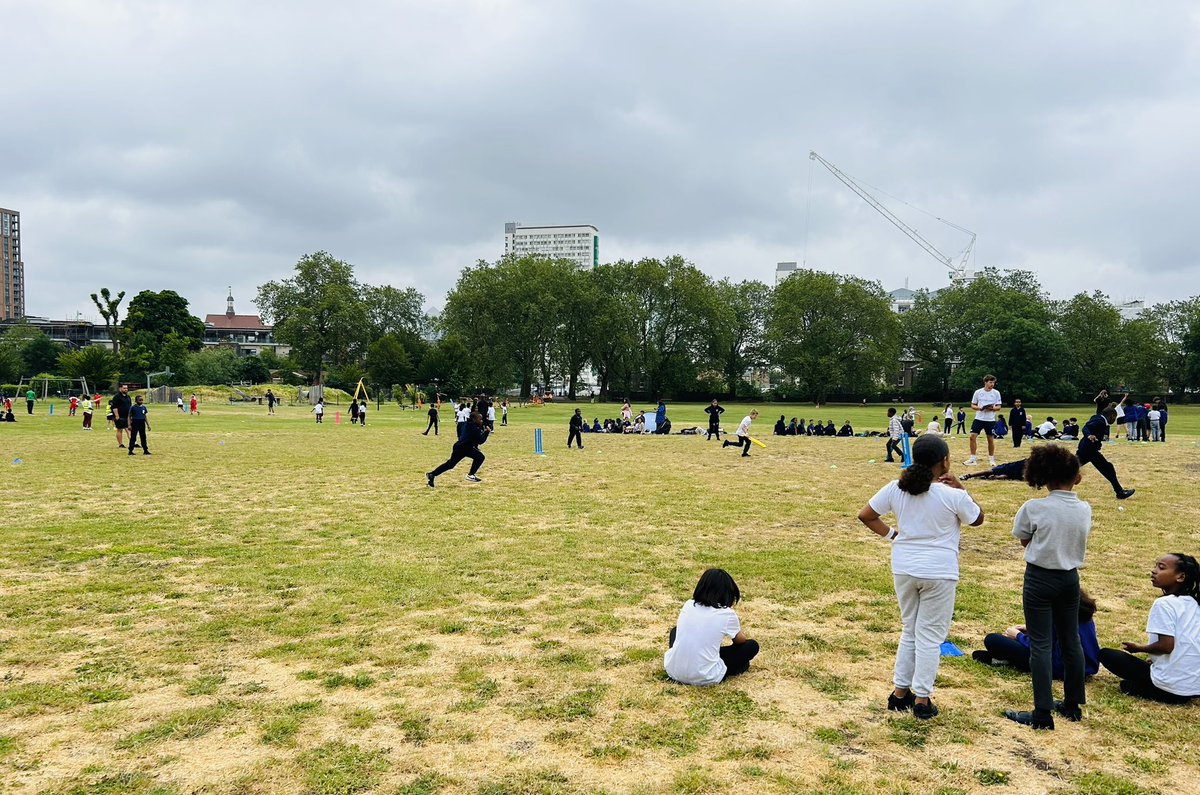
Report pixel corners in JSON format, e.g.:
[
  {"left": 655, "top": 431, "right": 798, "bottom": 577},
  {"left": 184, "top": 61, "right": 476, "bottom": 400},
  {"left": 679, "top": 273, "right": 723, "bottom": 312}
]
[{"left": 254, "top": 251, "right": 370, "bottom": 382}]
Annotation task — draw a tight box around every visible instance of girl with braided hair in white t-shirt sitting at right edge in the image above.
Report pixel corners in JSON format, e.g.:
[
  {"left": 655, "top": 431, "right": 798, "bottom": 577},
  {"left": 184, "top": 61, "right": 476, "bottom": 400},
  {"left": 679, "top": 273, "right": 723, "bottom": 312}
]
[{"left": 1100, "top": 552, "right": 1200, "bottom": 704}]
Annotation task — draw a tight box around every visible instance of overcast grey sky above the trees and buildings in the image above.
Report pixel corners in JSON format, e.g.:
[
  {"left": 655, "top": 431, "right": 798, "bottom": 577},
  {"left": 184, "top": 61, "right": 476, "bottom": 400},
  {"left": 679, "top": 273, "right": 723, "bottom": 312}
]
[{"left": 0, "top": 0, "right": 1200, "bottom": 321}]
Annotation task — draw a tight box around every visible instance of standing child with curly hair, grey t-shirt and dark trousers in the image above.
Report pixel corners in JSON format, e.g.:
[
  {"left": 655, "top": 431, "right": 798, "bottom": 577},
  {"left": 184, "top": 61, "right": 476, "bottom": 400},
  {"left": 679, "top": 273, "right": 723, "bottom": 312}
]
[{"left": 1004, "top": 444, "right": 1092, "bottom": 731}]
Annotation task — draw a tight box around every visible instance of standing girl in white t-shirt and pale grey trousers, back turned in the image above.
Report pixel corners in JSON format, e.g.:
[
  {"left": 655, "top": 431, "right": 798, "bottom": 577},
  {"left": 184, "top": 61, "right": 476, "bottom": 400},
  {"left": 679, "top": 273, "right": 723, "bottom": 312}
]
[{"left": 858, "top": 434, "right": 983, "bottom": 719}]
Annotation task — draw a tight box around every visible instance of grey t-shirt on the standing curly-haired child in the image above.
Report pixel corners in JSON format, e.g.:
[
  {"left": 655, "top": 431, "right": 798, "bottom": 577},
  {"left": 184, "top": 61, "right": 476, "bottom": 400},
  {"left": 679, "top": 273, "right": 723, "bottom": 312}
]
[{"left": 1013, "top": 491, "right": 1092, "bottom": 572}]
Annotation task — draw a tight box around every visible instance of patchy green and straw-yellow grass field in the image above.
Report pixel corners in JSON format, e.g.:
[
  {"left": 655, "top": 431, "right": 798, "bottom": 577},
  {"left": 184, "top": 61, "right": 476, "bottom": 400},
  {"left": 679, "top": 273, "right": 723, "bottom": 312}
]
[{"left": 0, "top": 405, "right": 1200, "bottom": 795}]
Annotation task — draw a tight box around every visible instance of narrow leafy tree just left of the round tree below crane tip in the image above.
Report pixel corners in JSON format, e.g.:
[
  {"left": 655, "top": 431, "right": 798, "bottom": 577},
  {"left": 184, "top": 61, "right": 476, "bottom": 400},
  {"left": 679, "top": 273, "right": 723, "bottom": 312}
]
[{"left": 710, "top": 279, "right": 770, "bottom": 399}]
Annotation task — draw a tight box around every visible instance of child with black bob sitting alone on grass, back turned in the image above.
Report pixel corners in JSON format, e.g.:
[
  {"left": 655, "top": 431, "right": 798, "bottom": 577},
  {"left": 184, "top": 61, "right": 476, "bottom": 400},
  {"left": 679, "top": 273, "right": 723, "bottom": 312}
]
[{"left": 662, "top": 569, "right": 758, "bottom": 685}]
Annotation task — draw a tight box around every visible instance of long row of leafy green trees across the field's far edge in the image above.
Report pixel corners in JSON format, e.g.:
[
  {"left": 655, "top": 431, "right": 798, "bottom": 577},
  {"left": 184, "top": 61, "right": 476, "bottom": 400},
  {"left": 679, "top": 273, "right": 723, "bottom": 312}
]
[{"left": 0, "top": 252, "right": 1200, "bottom": 402}]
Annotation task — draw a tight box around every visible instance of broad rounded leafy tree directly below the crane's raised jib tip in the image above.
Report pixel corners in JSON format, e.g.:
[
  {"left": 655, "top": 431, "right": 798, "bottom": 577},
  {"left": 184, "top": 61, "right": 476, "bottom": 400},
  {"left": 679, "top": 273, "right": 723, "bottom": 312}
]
[{"left": 766, "top": 270, "right": 900, "bottom": 402}]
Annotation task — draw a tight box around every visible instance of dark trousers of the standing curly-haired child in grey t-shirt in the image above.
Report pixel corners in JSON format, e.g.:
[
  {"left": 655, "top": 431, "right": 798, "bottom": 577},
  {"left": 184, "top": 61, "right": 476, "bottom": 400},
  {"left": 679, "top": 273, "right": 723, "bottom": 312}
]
[{"left": 1021, "top": 563, "right": 1087, "bottom": 717}]
